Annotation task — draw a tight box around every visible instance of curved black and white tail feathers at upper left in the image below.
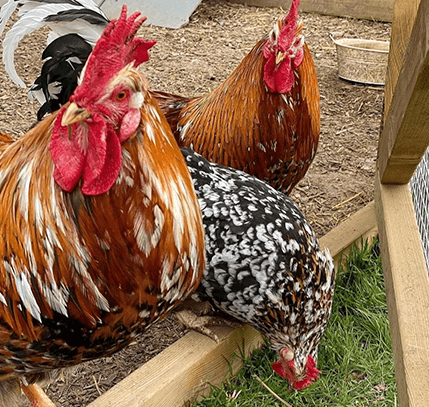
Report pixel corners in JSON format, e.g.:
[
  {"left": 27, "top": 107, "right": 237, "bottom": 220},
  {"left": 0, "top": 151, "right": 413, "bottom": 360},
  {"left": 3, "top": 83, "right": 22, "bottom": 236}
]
[{"left": 0, "top": 0, "right": 110, "bottom": 120}]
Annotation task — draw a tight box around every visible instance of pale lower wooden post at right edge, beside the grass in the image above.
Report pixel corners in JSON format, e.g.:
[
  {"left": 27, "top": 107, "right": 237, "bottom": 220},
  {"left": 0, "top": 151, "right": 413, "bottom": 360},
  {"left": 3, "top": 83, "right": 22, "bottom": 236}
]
[{"left": 376, "top": 177, "right": 429, "bottom": 407}]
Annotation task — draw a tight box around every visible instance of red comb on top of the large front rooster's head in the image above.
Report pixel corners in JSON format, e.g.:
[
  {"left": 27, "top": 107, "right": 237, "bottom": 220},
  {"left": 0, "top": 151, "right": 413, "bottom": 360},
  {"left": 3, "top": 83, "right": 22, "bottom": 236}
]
[{"left": 72, "top": 5, "right": 156, "bottom": 99}]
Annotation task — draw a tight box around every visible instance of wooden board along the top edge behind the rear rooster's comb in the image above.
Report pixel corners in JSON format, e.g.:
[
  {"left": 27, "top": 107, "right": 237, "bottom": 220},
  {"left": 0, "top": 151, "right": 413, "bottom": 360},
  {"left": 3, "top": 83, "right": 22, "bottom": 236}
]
[{"left": 232, "top": 0, "right": 394, "bottom": 21}]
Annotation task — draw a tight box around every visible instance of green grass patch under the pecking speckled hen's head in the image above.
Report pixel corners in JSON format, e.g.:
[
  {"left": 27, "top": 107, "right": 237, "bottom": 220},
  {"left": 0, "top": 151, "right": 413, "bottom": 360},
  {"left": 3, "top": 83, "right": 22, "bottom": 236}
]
[{"left": 194, "top": 244, "right": 397, "bottom": 407}]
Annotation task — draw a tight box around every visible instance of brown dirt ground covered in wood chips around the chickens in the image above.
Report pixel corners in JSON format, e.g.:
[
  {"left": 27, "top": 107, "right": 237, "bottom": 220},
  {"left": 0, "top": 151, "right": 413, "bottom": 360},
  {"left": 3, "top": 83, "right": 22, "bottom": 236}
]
[{"left": 0, "top": 0, "right": 390, "bottom": 407}]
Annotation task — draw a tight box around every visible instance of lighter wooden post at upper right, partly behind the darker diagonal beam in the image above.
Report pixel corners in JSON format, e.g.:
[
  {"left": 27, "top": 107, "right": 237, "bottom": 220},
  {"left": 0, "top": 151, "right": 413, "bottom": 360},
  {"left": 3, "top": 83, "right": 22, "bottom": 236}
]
[{"left": 384, "top": 0, "right": 421, "bottom": 119}]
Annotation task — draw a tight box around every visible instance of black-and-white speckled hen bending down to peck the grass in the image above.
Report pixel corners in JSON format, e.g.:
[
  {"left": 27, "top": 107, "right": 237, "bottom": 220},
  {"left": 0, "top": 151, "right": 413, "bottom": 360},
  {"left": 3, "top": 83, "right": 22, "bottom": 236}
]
[{"left": 182, "top": 148, "right": 335, "bottom": 389}]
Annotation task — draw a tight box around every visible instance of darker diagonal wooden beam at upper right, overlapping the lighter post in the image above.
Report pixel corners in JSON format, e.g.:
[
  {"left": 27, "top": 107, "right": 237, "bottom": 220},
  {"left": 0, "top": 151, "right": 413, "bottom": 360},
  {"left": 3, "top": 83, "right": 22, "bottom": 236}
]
[{"left": 378, "top": 0, "right": 429, "bottom": 184}]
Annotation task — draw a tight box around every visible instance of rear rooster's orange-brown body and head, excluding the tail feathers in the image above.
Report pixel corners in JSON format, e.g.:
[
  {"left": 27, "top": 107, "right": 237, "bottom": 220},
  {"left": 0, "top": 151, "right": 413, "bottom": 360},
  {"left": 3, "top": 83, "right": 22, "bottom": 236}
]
[{"left": 153, "top": 0, "right": 320, "bottom": 194}]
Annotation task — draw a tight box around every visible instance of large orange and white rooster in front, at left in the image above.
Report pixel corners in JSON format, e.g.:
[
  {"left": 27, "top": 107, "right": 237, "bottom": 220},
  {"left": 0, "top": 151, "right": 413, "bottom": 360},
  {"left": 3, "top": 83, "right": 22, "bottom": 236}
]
[{"left": 0, "top": 6, "right": 205, "bottom": 407}]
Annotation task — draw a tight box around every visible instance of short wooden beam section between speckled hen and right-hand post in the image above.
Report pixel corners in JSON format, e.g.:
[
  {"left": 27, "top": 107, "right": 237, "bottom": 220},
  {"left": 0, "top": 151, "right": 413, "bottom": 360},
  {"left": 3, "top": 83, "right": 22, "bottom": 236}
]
[{"left": 320, "top": 201, "right": 378, "bottom": 267}]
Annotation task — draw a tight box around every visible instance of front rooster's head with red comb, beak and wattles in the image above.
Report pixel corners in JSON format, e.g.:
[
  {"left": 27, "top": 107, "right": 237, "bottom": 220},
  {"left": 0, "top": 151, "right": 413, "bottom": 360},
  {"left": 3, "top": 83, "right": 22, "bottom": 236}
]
[{"left": 50, "top": 9, "right": 155, "bottom": 195}]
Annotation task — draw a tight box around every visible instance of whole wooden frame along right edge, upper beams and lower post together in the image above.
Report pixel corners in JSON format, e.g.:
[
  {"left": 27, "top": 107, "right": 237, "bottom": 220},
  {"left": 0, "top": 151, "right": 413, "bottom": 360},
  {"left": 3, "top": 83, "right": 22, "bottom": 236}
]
[{"left": 375, "top": 0, "right": 429, "bottom": 407}]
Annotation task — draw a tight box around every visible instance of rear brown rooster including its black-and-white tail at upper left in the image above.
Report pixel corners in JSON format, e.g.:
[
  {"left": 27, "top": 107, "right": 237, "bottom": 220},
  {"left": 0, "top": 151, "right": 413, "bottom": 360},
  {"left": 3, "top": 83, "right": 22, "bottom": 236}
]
[{"left": 0, "top": 0, "right": 320, "bottom": 194}]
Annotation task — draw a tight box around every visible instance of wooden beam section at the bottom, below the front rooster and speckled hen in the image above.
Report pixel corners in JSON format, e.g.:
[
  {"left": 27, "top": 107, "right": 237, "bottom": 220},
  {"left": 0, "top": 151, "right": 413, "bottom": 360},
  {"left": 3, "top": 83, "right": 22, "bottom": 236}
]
[{"left": 88, "top": 325, "right": 263, "bottom": 407}]
